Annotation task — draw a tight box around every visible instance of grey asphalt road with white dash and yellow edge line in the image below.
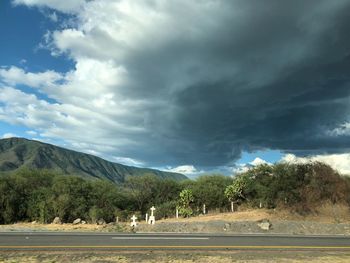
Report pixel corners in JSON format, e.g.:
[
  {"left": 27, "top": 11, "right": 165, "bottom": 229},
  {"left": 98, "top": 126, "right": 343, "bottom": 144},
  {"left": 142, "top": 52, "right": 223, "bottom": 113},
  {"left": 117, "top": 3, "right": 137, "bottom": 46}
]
[{"left": 0, "top": 232, "right": 350, "bottom": 251}]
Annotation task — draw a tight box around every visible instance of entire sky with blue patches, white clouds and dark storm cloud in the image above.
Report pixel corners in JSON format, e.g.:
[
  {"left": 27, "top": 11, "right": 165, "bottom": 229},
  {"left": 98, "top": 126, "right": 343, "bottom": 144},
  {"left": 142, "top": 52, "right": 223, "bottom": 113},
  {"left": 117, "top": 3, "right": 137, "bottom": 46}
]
[{"left": 0, "top": 0, "right": 350, "bottom": 176}]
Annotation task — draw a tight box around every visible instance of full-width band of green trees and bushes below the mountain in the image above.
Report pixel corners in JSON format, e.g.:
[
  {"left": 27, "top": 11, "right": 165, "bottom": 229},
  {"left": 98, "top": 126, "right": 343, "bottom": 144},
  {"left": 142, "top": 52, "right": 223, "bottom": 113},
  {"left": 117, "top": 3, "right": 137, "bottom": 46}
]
[{"left": 0, "top": 162, "right": 350, "bottom": 224}]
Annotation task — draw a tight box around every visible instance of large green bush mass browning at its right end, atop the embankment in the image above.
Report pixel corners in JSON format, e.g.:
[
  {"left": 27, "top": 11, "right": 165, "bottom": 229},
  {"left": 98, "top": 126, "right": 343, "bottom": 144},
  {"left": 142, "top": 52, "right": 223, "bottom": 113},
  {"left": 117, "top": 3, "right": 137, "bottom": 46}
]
[{"left": 230, "top": 162, "right": 350, "bottom": 214}]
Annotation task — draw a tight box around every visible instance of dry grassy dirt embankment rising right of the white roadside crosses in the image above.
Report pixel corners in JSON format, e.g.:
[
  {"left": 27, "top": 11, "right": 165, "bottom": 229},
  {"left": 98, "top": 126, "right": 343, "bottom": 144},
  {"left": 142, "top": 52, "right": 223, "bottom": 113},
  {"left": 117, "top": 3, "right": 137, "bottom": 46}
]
[{"left": 138, "top": 204, "right": 350, "bottom": 235}]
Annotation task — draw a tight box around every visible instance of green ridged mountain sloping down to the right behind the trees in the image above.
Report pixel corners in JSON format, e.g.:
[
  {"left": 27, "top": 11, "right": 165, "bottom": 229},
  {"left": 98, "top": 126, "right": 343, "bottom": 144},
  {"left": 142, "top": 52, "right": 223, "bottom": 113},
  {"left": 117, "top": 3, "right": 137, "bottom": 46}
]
[{"left": 0, "top": 138, "right": 187, "bottom": 183}]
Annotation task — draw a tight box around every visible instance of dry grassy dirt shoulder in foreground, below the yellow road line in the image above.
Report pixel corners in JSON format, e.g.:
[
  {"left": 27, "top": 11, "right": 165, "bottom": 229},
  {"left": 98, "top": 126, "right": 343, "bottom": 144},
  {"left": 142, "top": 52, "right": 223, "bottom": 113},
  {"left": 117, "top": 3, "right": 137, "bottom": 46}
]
[{"left": 0, "top": 251, "right": 350, "bottom": 263}]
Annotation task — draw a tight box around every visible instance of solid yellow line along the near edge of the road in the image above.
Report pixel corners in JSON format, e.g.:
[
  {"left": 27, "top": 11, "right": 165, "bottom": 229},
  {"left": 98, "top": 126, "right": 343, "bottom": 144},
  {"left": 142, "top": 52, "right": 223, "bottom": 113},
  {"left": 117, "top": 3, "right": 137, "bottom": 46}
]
[{"left": 0, "top": 245, "right": 350, "bottom": 250}]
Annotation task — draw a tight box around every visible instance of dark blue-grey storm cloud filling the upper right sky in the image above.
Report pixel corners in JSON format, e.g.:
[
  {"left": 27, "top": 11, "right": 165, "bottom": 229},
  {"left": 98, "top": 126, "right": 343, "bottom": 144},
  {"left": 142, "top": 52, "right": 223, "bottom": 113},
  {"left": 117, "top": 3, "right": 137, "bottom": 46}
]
[{"left": 113, "top": 1, "right": 350, "bottom": 166}]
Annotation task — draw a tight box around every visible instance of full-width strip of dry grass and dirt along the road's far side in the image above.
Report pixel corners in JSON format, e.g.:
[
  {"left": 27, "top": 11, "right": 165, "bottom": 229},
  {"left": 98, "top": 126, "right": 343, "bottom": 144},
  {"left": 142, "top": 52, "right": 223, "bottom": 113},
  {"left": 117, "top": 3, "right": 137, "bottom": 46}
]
[{"left": 0, "top": 204, "right": 350, "bottom": 235}]
